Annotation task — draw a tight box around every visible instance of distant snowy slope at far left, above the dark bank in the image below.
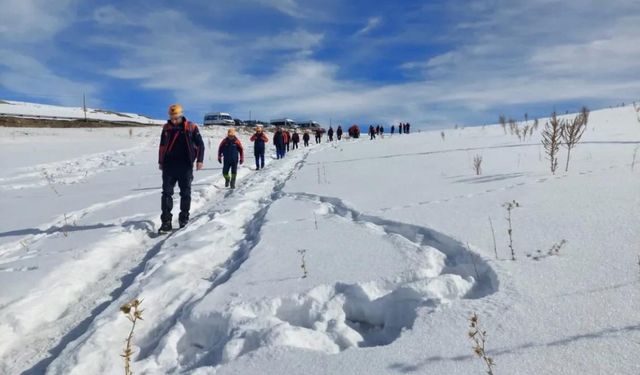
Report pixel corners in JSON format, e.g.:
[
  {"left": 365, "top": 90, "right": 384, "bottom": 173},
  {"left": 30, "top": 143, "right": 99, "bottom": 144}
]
[{"left": 0, "top": 100, "right": 164, "bottom": 124}]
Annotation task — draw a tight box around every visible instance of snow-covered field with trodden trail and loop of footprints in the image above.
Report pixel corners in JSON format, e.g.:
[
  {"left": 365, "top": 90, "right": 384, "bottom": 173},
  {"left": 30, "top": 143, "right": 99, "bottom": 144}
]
[{"left": 0, "top": 107, "right": 640, "bottom": 375}]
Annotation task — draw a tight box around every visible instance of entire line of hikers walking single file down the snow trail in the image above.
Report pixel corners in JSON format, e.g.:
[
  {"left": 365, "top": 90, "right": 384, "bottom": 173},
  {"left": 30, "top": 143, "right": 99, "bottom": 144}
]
[{"left": 158, "top": 104, "right": 409, "bottom": 233}]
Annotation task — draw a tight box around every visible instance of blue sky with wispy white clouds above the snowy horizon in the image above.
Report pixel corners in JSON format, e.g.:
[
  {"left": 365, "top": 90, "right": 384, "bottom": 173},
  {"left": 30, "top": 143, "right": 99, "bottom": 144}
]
[{"left": 0, "top": 0, "right": 640, "bottom": 126}]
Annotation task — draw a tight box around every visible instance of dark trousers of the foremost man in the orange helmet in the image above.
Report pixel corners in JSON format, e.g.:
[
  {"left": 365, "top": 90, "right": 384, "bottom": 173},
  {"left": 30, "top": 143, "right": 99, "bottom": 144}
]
[{"left": 160, "top": 167, "right": 193, "bottom": 223}]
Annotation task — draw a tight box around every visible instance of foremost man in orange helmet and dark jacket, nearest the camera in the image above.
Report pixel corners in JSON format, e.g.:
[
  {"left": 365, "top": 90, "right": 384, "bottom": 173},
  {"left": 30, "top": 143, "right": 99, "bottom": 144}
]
[{"left": 158, "top": 104, "right": 204, "bottom": 232}]
